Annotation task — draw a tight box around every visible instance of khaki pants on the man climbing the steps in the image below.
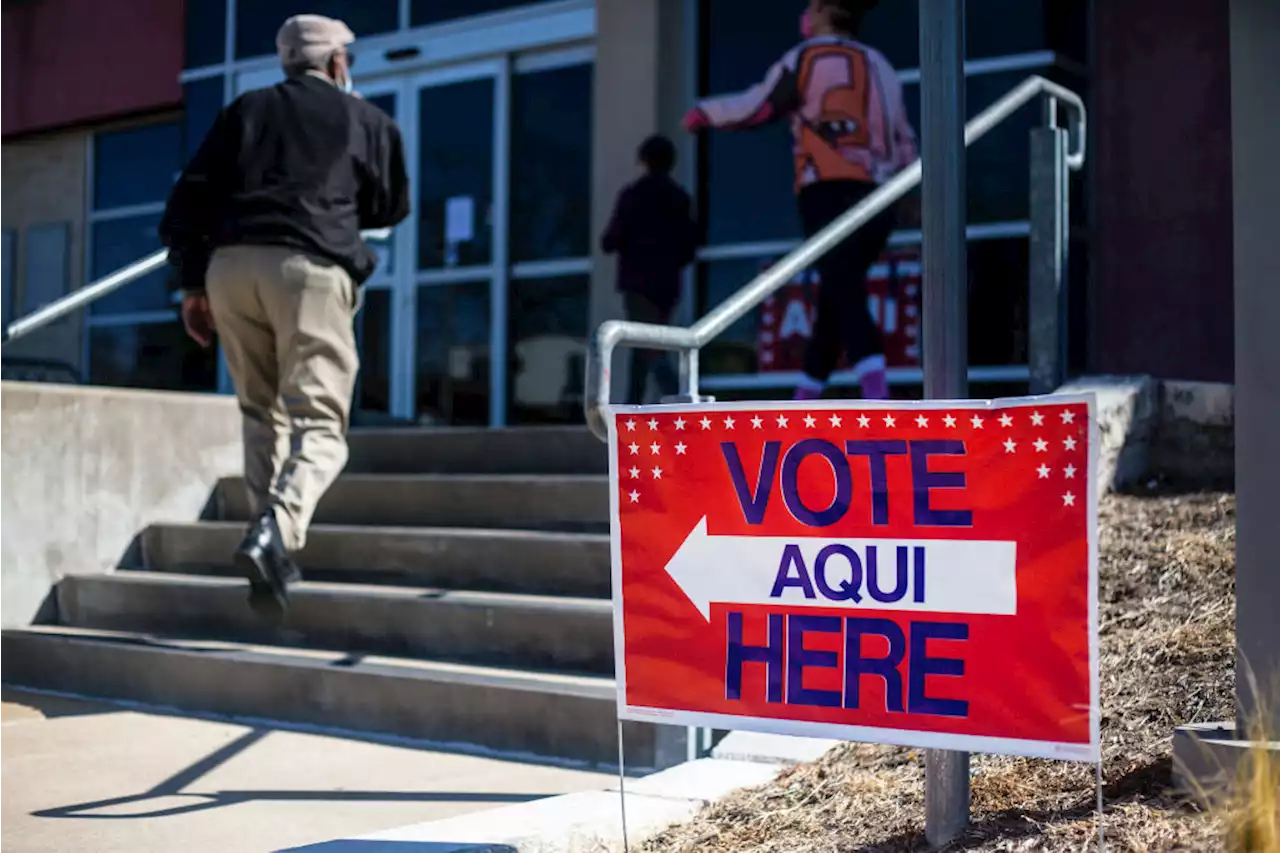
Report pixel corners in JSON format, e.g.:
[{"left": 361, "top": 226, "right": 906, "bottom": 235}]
[{"left": 206, "top": 246, "right": 360, "bottom": 551}]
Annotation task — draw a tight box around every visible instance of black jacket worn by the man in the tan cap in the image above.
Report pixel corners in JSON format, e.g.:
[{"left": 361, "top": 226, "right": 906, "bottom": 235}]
[{"left": 160, "top": 74, "right": 410, "bottom": 291}]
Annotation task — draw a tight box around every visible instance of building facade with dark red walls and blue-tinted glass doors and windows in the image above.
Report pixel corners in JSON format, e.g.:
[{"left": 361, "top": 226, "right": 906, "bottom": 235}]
[{"left": 0, "top": 0, "right": 1233, "bottom": 425}]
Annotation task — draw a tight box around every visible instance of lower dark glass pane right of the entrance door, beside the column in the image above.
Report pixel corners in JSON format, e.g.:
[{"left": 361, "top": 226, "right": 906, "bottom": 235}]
[{"left": 511, "top": 275, "right": 590, "bottom": 424}]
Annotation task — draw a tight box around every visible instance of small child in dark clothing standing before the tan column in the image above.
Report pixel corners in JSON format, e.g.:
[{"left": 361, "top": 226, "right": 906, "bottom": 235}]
[{"left": 602, "top": 136, "right": 698, "bottom": 403}]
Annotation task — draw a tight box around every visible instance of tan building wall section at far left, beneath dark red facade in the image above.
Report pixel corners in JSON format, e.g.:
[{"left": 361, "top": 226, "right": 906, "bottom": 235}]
[{"left": 0, "top": 129, "right": 90, "bottom": 370}]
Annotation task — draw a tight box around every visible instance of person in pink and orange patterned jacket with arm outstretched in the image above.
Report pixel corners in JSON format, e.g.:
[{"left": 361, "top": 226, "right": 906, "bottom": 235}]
[{"left": 684, "top": 0, "right": 918, "bottom": 400}]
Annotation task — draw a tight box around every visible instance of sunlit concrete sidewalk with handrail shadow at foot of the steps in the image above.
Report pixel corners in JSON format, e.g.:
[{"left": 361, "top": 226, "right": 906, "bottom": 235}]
[{"left": 0, "top": 686, "right": 612, "bottom": 853}]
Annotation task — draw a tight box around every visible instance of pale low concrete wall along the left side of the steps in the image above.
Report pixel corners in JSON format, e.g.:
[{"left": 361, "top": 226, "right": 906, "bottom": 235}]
[{"left": 0, "top": 383, "right": 242, "bottom": 629}]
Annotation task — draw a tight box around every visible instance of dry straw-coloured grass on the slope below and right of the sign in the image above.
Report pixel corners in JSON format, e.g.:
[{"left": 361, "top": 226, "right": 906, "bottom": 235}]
[{"left": 644, "top": 494, "right": 1235, "bottom": 853}]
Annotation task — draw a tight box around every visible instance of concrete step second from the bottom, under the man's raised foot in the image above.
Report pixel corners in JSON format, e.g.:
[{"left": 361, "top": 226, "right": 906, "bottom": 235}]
[{"left": 56, "top": 571, "right": 613, "bottom": 674}]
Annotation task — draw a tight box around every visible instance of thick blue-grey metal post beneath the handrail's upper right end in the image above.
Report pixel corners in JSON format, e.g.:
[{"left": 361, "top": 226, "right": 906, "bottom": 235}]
[{"left": 1027, "top": 127, "right": 1070, "bottom": 394}]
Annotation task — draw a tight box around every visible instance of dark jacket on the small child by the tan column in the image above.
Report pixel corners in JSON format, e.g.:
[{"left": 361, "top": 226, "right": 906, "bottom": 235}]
[{"left": 602, "top": 174, "right": 698, "bottom": 310}]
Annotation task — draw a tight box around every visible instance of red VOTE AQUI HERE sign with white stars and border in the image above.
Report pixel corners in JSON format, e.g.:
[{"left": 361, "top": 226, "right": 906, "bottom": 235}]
[{"left": 609, "top": 394, "right": 1100, "bottom": 761}]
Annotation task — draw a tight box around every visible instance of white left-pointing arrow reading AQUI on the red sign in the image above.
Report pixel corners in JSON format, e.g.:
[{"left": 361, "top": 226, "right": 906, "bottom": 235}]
[{"left": 667, "top": 516, "right": 1018, "bottom": 621}]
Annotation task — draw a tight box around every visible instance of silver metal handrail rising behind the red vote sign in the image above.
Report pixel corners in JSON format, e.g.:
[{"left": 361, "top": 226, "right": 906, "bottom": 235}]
[{"left": 585, "top": 76, "right": 1085, "bottom": 441}]
